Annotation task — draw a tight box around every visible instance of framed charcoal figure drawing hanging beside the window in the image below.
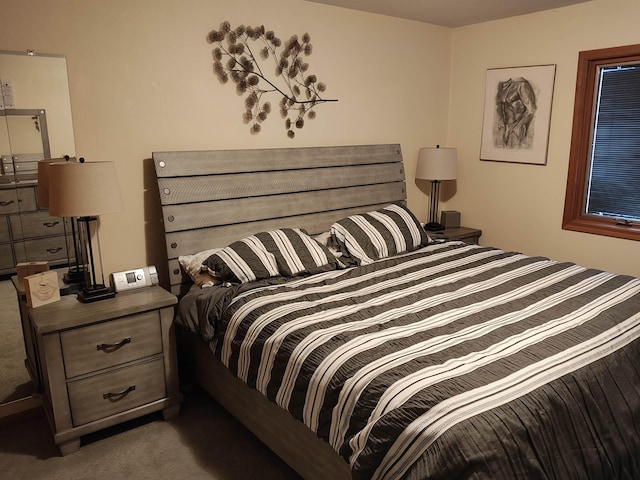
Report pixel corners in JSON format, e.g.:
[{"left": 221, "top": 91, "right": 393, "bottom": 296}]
[{"left": 480, "top": 64, "right": 556, "bottom": 165}]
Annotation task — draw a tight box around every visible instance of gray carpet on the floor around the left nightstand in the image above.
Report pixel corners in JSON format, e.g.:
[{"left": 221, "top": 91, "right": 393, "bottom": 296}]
[{"left": 0, "top": 389, "right": 299, "bottom": 480}]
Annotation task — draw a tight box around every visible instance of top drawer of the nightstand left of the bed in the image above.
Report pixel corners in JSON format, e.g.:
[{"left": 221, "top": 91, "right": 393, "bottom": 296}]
[{"left": 60, "top": 311, "right": 162, "bottom": 378}]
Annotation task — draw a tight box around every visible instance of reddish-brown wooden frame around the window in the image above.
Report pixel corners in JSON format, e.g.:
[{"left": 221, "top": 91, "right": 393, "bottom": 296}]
[{"left": 562, "top": 44, "right": 640, "bottom": 241}]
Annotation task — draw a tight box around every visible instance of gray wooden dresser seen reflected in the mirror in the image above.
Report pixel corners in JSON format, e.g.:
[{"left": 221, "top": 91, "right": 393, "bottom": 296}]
[{"left": 0, "top": 181, "right": 71, "bottom": 275}]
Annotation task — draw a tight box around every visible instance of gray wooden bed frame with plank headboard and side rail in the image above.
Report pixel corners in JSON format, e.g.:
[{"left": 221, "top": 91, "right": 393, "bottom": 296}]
[{"left": 153, "top": 144, "right": 406, "bottom": 480}]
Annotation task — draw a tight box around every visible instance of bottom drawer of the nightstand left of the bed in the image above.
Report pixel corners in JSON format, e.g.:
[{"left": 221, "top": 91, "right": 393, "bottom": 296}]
[{"left": 67, "top": 357, "right": 166, "bottom": 427}]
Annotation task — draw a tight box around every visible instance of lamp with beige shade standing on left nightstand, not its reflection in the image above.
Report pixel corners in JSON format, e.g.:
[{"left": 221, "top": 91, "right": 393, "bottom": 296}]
[{"left": 48, "top": 159, "right": 123, "bottom": 302}]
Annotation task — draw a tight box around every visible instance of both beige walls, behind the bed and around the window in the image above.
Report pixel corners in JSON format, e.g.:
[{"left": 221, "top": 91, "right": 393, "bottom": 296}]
[{"left": 0, "top": 0, "right": 640, "bottom": 276}]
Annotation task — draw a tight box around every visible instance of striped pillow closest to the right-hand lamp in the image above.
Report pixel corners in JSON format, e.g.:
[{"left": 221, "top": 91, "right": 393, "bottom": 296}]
[{"left": 331, "top": 203, "right": 429, "bottom": 265}]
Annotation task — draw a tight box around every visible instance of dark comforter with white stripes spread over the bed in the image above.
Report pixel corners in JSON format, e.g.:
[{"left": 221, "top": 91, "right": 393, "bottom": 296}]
[{"left": 192, "top": 242, "right": 640, "bottom": 479}]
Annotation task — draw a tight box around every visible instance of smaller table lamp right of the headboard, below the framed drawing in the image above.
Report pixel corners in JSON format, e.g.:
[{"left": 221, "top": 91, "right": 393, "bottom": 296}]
[{"left": 416, "top": 145, "right": 458, "bottom": 231}]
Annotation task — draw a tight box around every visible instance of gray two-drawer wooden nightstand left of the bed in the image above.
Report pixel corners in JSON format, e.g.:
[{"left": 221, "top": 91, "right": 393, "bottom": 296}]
[{"left": 26, "top": 286, "right": 182, "bottom": 455}]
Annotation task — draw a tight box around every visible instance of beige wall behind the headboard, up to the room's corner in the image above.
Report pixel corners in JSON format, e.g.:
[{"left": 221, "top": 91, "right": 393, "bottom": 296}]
[{"left": 0, "top": 0, "right": 452, "bottom": 280}]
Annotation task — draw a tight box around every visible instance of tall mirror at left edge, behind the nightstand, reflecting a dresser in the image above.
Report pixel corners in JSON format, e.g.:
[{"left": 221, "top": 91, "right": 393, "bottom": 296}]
[{"left": 0, "top": 51, "right": 75, "bottom": 418}]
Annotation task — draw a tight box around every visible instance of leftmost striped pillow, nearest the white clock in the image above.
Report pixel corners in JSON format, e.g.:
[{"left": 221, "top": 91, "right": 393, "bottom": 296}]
[{"left": 203, "top": 235, "right": 280, "bottom": 283}]
